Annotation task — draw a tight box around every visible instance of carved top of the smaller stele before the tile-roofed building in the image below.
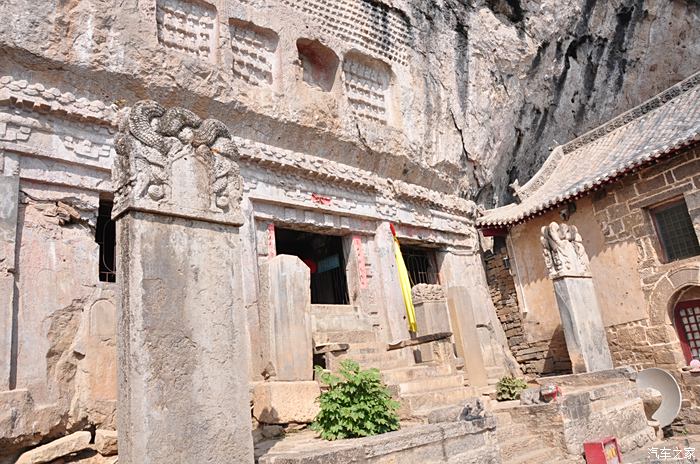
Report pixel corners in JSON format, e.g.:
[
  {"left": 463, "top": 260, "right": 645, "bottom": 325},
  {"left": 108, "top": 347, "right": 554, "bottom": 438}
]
[{"left": 540, "top": 222, "right": 591, "bottom": 279}]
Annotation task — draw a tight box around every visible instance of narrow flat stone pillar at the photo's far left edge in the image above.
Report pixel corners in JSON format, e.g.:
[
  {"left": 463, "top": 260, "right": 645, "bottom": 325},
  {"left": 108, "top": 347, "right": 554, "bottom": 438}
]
[{"left": 0, "top": 174, "right": 19, "bottom": 391}]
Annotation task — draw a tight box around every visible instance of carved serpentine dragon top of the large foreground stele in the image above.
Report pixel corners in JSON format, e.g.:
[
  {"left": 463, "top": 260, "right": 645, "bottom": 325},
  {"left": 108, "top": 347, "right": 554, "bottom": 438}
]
[{"left": 112, "top": 100, "right": 243, "bottom": 225}]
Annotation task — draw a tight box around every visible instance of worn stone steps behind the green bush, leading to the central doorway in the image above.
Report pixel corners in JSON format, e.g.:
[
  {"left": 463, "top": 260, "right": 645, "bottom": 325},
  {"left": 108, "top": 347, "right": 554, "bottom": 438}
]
[{"left": 314, "top": 331, "right": 476, "bottom": 421}]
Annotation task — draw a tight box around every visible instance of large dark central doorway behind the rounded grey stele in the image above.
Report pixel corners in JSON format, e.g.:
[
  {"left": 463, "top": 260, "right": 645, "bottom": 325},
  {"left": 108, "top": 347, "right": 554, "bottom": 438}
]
[{"left": 275, "top": 227, "right": 350, "bottom": 304}]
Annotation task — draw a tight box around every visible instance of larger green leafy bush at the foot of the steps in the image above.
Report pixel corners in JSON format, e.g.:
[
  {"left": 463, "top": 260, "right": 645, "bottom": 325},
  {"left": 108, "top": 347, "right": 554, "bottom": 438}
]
[{"left": 311, "top": 360, "right": 399, "bottom": 440}]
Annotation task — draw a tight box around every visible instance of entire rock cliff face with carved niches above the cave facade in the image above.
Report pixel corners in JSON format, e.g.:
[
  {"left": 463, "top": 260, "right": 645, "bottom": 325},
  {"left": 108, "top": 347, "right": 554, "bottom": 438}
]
[{"left": 0, "top": 0, "right": 700, "bottom": 206}]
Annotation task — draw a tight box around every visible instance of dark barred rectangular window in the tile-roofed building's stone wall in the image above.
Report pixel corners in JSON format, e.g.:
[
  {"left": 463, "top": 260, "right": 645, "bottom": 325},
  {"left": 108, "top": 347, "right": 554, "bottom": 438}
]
[{"left": 651, "top": 200, "right": 700, "bottom": 262}]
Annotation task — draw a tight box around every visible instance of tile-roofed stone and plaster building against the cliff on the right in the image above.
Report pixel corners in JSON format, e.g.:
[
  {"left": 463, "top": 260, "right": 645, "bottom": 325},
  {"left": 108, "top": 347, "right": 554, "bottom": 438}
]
[{"left": 478, "top": 69, "right": 700, "bottom": 424}]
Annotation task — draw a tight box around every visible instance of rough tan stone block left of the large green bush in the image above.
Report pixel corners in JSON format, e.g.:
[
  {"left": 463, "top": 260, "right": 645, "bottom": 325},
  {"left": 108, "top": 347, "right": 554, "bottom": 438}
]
[{"left": 253, "top": 380, "right": 321, "bottom": 424}]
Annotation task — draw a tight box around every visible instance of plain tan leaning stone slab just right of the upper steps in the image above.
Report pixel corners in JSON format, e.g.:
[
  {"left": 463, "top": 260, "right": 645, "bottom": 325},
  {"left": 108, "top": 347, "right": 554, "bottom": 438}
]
[{"left": 447, "top": 287, "right": 489, "bottom": 387}]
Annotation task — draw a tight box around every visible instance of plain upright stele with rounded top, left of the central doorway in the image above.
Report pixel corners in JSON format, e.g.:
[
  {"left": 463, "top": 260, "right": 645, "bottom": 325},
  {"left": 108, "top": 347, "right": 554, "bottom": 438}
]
[{"left": 260, "top": 255, "right": 314, "bottom": 381}]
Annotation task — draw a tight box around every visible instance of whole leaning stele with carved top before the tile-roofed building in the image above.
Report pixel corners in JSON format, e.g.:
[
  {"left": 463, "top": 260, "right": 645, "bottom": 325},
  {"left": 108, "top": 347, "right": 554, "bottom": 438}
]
[{"left": 540, "top": 222, "right": 613, "bottom": 374}]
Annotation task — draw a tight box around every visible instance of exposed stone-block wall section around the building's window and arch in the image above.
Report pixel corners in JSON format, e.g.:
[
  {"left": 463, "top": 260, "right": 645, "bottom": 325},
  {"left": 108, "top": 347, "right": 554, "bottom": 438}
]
[{"left": 592, "top": 145, "right": 700, "bottom": 370}]
